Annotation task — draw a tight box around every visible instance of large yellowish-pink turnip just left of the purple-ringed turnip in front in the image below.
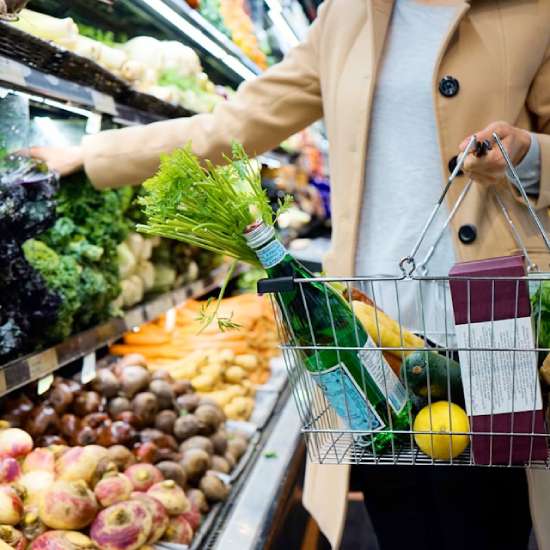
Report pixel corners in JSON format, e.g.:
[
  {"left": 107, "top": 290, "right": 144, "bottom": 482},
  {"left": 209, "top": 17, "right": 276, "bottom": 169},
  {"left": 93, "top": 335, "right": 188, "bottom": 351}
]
[{"left": 39, "top": 481, "right": 98, "bottom": 530}]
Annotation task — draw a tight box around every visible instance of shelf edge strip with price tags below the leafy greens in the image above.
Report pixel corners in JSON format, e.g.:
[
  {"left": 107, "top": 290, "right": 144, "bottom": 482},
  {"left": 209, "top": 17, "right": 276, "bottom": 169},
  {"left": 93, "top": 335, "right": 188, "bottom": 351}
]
[{"left": 0, "top": 265, "right": 245, "bottom": 397}]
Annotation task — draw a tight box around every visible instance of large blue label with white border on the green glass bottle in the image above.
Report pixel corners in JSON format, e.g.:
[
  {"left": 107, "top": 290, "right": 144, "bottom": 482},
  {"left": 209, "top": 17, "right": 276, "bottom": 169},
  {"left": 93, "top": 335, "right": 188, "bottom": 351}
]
[{"left": 310, "top": 363, "right": 385, "bottom": 432}]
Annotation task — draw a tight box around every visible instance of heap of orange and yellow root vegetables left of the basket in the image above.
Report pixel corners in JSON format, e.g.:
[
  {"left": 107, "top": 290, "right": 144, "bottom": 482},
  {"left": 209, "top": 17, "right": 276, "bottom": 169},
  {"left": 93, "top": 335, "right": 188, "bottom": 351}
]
[{"left": 110, "top": 294, "right": 278, "bottom": 422}]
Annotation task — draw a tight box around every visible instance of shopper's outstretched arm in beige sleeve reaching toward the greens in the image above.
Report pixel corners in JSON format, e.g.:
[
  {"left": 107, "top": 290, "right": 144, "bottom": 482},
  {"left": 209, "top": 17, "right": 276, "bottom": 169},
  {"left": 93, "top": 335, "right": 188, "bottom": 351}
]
[{"left": 31, "top": 3, "right": 327, "bottom": 188}]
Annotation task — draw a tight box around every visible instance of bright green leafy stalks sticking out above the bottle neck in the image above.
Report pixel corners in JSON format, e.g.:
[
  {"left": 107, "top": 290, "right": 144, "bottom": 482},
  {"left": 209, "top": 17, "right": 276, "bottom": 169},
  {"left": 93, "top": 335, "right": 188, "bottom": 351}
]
[{"left": 137, "top": 144, "right": 289, "bottom": 267}]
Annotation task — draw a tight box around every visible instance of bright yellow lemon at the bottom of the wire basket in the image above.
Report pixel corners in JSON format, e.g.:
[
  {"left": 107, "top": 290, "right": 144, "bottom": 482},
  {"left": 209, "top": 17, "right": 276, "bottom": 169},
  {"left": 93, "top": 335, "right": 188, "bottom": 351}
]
[{"left": 413, "top": 401, "right": 470, "bottom": 460}]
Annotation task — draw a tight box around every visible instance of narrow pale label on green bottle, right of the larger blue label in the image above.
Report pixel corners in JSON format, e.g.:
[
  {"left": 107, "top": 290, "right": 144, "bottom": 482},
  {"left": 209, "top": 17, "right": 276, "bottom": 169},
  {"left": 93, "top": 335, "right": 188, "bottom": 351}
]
[{"left": 359, "top": 336, "right": 407, "bottom": 414}]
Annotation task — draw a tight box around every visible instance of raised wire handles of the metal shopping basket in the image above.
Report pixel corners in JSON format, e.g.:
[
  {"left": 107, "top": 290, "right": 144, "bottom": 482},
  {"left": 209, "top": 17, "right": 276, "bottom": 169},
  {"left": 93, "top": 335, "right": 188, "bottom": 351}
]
[{"left": 399, "top": 132, "right": 550, "bottom": 278}]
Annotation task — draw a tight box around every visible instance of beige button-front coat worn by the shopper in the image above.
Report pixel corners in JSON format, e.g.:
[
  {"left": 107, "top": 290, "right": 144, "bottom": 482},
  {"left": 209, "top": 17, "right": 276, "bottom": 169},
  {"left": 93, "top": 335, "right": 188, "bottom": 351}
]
[{"left": 84, "top": 0, "right": 550, "bottom": 550}]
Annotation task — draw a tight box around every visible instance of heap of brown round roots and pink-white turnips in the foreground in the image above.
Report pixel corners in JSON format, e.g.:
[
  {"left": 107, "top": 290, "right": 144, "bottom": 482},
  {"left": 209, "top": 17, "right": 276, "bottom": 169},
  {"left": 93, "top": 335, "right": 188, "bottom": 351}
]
[{"left": 0, "top": 354, "right": 252, "bottom": 550}]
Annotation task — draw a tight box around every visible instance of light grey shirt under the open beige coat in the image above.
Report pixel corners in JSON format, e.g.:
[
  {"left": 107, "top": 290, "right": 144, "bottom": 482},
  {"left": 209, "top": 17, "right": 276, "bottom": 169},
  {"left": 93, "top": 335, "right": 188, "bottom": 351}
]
[{"left": 356, "top": 0, "right": 540, "bottom": 338}]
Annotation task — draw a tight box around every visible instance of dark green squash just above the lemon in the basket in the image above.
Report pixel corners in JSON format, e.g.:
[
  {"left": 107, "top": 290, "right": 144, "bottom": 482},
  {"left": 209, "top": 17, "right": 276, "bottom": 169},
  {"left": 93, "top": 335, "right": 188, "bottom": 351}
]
[{"left": 401, "top": 350, "right": 464, "bottom": 406}]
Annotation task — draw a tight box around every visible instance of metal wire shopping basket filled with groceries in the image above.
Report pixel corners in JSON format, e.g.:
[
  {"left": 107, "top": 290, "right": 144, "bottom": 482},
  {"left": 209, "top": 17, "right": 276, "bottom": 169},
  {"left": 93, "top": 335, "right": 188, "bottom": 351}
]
[{"left": 258, "top": 134, "right": 550, "bottom": 468}]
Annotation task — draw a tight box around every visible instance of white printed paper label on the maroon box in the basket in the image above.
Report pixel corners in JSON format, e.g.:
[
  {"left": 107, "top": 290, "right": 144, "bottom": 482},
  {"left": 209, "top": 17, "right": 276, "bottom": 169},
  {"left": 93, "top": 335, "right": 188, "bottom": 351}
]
[{"left": 456, "top": 317, "right": 542, "bottom": 416}]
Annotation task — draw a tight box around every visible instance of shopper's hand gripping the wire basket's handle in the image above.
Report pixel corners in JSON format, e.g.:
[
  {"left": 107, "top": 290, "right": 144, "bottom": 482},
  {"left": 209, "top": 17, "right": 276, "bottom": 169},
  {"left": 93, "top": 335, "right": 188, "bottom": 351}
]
[{"left": 460, "top": 122, "right": 531, "bottom": 184}]
